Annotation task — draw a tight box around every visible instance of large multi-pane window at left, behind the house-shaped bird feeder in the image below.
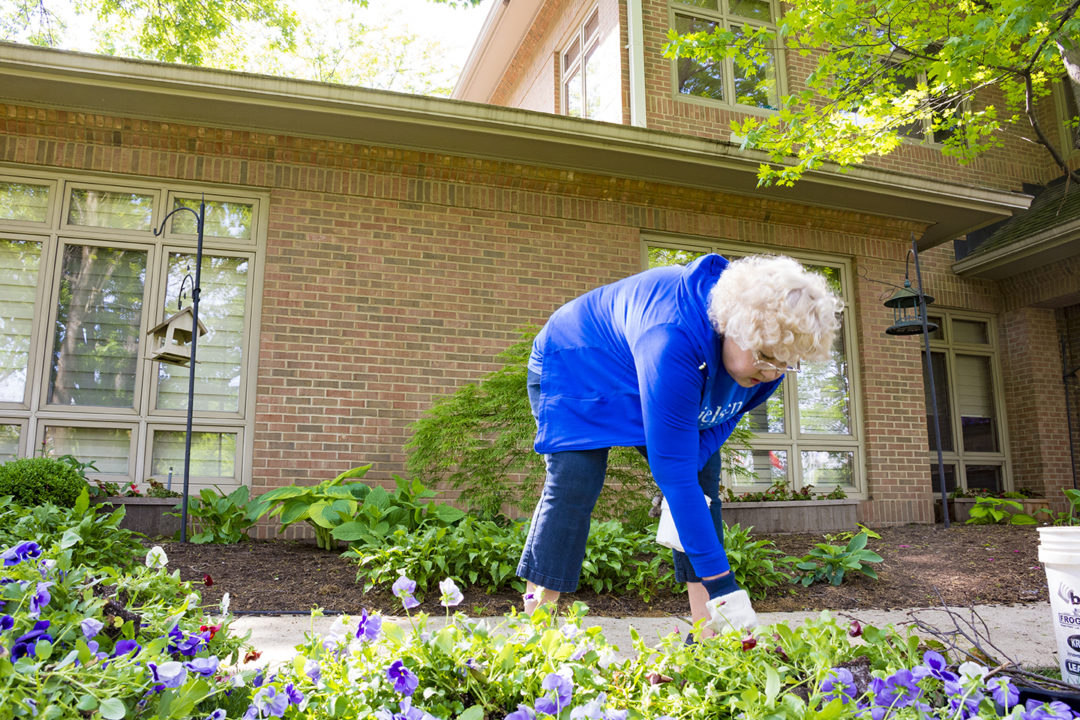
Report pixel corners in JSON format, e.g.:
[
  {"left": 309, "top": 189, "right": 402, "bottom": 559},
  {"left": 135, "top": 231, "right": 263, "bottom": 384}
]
[{"left": 0, "top": 175, "right": 264, "bottom": 486}]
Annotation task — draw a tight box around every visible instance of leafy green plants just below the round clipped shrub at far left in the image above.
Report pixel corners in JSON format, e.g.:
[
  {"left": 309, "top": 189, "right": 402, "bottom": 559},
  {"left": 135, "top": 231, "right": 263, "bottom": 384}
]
[{"left": 0, "top": 491, "right": 143, "bottom": 568}]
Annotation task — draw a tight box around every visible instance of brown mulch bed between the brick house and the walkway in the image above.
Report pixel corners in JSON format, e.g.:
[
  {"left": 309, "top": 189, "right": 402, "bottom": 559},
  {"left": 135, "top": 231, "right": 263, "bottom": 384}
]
[{"left": 156, "top": 525, "right": 1048, "bottom": 617}]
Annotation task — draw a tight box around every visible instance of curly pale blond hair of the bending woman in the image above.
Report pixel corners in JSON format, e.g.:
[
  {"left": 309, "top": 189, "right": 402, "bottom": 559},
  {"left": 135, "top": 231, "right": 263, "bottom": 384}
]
[{"left": 708, "top": 255, "right": 843, "bottom": 365}]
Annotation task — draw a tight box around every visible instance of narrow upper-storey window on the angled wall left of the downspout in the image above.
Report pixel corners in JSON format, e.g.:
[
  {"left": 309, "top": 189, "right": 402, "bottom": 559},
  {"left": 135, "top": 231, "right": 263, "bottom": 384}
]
[{"left": 562, "top": 9, "right": 622, "bottom": 123}]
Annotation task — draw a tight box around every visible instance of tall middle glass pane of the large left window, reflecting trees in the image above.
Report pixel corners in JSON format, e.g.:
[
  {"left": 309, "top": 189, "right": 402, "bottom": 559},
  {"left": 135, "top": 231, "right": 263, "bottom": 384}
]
[{"left": 49, "top": 245, "right": 146, "bottom": 408}]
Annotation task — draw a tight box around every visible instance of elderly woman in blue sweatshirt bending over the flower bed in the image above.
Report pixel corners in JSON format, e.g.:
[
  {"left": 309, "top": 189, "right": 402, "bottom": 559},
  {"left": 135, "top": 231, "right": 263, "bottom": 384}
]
[{"left": 517, "top": 255, "right": 843, "bottom": 634}]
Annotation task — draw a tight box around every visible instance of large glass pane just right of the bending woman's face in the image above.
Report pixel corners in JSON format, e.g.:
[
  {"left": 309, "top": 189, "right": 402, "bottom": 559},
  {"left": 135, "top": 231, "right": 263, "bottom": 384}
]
[{"left": 795, "top": 317, "right": 851, "bottom": 435}]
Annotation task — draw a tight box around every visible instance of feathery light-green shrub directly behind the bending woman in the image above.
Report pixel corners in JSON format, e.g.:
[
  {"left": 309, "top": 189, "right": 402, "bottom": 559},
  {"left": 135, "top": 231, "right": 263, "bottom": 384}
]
[{"left": 405, "top": 327, "right": 653, "bottom": 519}]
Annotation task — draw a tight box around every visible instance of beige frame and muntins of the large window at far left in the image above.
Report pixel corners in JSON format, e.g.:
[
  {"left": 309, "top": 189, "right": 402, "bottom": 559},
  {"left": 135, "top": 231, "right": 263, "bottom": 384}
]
[{"left": 0, "top": 165, "right": 270, "bottom": 492}]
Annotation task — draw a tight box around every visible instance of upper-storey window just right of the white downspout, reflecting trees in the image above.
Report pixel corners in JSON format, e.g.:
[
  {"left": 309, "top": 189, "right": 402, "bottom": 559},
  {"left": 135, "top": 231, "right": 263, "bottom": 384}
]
[{"left": 672, "top": 0, "right": 780, "bottom": 109}]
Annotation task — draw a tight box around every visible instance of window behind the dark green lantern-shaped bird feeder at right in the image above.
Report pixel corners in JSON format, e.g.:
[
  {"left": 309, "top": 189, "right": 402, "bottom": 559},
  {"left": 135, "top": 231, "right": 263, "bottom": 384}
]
[{"left": 922, "top": 311, "right": 1009, "bottom": 493}]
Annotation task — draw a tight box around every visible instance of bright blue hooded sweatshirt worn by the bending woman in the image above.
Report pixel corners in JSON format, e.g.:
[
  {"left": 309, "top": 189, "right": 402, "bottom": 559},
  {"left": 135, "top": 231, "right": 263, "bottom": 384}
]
[{"left": 529, "top": 255, "right": 781, "bottom": 576}]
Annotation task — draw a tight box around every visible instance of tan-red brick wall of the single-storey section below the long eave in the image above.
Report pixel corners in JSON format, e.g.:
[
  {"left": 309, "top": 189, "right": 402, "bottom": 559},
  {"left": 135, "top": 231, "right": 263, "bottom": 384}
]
[{"left": 0, "top": 99, "right": 1059, "bottom": 524}]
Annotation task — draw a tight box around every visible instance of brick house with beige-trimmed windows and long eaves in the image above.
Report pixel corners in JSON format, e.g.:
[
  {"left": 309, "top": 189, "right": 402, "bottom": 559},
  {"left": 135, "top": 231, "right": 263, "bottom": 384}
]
[{"left": 0, "top": 0, "right": 1080, "bottom": 524}]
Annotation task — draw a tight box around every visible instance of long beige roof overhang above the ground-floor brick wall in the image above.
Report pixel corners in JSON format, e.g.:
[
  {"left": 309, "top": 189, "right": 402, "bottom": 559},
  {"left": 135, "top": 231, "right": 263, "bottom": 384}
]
[{"left": 0, "top": 42, "right": 1031, "bottom": 247}]
